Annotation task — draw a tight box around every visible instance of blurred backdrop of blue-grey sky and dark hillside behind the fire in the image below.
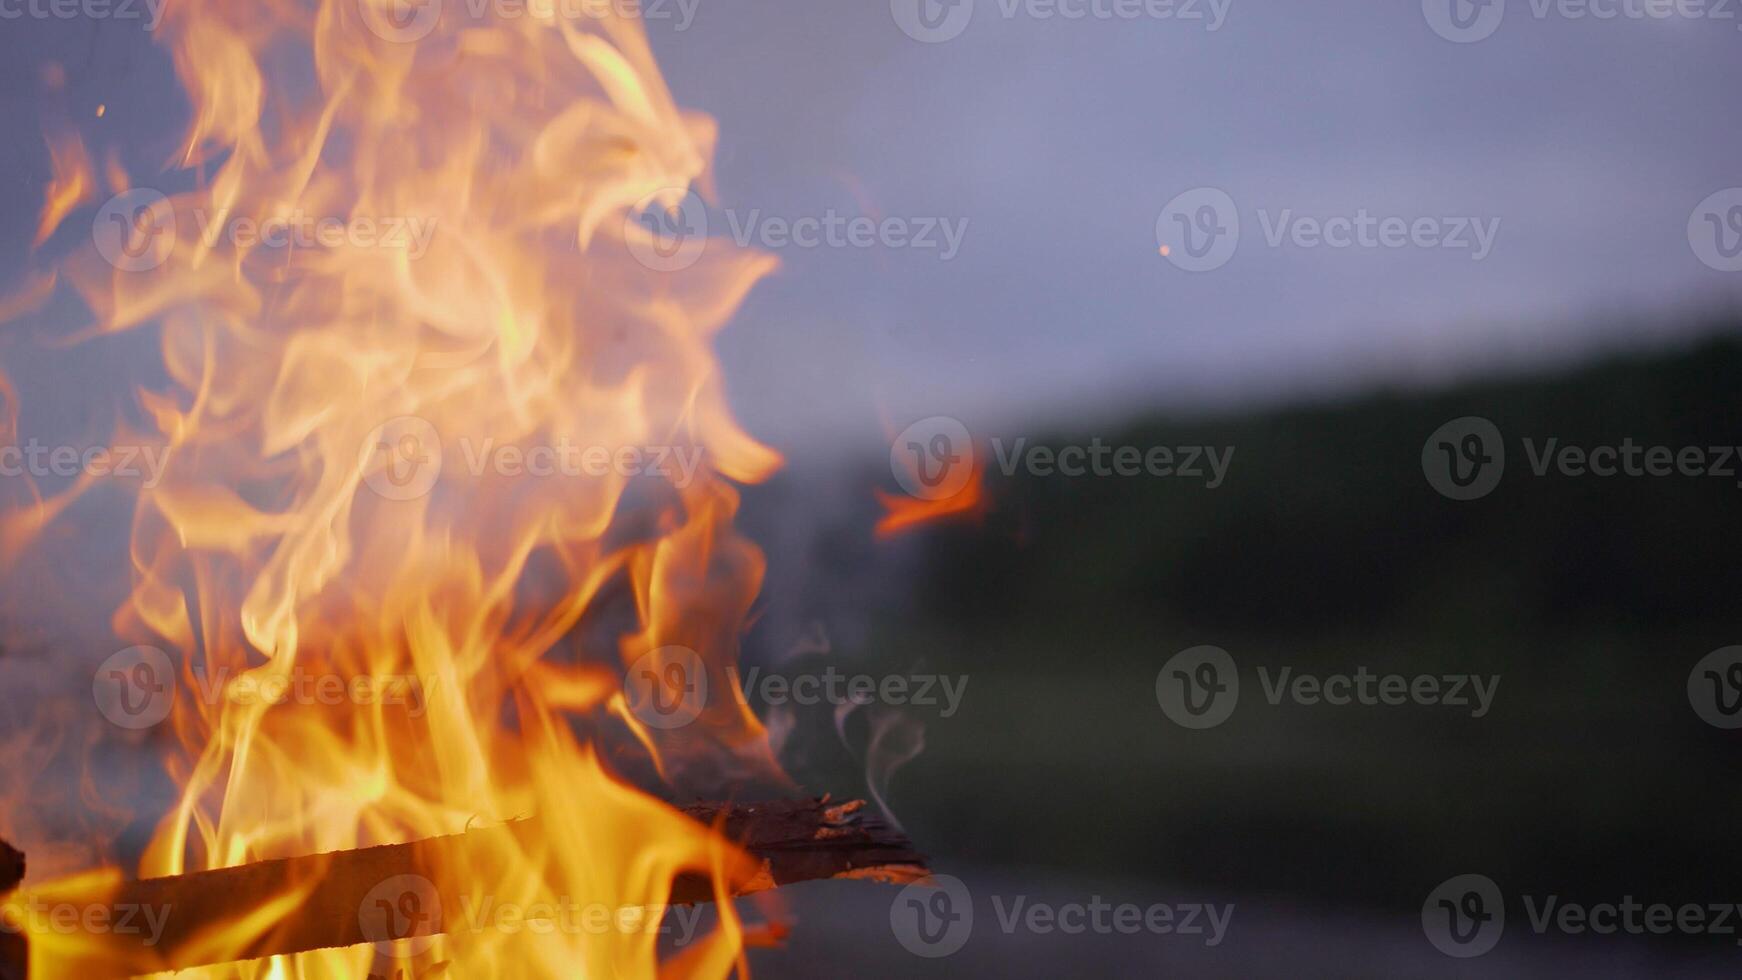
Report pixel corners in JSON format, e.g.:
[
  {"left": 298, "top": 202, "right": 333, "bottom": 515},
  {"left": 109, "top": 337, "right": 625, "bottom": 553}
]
[{"left": 0, "top": 0, "right": 1742, "bottom": 977}]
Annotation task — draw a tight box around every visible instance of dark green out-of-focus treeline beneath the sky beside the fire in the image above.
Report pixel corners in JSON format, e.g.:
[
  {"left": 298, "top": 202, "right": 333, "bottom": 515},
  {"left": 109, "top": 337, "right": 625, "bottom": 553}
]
[{"left": 783, "top": 331, "right": 1742, "bottom": 914}]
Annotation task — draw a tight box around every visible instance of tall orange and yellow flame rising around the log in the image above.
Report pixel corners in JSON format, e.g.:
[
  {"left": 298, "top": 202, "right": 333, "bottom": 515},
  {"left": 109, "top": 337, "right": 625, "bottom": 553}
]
[{"left": 0, "top": 0, "right": 782, "bottom": 978}]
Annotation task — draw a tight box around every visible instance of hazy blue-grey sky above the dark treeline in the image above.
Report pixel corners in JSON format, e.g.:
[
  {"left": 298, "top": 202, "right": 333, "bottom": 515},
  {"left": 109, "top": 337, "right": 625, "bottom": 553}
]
[{"left": 0, "top": 0, "right": 1742, "bottom": 459}]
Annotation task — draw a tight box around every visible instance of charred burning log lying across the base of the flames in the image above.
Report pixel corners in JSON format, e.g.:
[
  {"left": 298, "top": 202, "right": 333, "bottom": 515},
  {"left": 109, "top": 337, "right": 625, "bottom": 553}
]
[{"left": 0, "top": 797, "right": 928, "bottom": 980}]
